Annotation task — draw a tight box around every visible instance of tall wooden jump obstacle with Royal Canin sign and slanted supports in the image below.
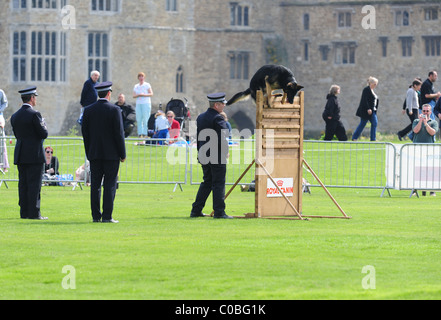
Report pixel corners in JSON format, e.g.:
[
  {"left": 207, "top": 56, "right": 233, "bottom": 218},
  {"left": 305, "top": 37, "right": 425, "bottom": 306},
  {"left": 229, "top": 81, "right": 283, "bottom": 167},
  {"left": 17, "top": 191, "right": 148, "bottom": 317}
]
[{"left": 220, "top": 83, "right": 351, "bottom": 220}]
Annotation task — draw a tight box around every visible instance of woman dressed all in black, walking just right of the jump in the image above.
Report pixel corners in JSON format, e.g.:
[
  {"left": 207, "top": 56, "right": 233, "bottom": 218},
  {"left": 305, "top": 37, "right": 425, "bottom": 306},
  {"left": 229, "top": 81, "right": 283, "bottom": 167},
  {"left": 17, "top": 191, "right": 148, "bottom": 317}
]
[{"left": 322, "top": 85, "right": 348, "bottom": 141}]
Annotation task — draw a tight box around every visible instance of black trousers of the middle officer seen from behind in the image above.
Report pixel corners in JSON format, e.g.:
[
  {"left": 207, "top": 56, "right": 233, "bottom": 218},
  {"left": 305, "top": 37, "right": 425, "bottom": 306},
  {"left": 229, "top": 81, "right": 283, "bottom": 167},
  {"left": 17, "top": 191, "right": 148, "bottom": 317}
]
[{"left": 90, "top": 160, "right": 120, "bottom": 220}]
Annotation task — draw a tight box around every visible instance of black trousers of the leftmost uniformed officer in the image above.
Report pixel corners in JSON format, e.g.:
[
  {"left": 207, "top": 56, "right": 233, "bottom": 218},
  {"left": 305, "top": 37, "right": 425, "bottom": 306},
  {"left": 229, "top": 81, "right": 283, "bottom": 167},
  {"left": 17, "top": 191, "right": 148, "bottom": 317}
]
[{"left": 17, "top": 163, "right": 44, "bottom": 219}]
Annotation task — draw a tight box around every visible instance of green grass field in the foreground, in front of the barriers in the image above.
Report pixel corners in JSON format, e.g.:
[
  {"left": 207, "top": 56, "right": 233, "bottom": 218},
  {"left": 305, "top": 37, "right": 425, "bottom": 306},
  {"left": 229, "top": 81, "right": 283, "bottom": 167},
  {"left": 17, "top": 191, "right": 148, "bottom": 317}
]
[{"left": 0, "top": 182, "right": 441, "bottom": 300}]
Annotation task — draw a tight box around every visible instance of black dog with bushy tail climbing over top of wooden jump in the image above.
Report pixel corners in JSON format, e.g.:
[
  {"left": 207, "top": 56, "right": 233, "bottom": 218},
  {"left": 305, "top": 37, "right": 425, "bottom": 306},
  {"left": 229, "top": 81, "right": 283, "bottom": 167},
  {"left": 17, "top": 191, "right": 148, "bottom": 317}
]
[{"left": 227, "top": 65, "right": 303, "bottom": 106}]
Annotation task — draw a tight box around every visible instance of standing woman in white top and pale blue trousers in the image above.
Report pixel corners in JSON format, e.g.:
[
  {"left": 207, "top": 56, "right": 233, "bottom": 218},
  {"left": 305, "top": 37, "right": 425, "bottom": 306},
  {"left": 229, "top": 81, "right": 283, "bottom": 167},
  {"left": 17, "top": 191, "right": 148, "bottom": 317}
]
[{"left": 133, "top": 72, "right": 153, "bottom": 138}]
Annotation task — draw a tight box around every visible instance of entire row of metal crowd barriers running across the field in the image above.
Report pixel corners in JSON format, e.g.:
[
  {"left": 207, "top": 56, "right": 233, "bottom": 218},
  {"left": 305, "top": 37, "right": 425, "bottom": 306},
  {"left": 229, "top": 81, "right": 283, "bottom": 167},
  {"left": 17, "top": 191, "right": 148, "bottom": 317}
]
[{"left": 0, "top": 136, "right": 441, "bottom": 195}]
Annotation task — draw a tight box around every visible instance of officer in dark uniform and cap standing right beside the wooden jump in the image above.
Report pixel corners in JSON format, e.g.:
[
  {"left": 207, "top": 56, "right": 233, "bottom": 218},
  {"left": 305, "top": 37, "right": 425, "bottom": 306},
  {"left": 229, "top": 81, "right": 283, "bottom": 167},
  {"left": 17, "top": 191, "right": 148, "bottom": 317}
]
[{"left": 190, "top": 92, "right": 232, "bottom": 219}]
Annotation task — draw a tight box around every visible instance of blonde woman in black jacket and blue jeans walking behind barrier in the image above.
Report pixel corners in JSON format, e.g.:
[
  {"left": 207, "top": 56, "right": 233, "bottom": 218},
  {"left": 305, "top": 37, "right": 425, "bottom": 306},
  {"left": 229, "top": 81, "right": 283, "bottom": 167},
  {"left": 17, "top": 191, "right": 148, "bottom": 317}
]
[{"left": 352, "top": 77, "right": 378, "bottom": 141}]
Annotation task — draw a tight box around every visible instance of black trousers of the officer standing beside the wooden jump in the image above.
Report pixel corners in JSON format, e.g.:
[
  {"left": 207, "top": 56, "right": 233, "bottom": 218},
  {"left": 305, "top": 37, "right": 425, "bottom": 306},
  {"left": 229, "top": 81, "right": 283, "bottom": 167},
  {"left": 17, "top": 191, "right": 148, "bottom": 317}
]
[{"left": 191, "top": 164, "right": 227, "bottom": 217}]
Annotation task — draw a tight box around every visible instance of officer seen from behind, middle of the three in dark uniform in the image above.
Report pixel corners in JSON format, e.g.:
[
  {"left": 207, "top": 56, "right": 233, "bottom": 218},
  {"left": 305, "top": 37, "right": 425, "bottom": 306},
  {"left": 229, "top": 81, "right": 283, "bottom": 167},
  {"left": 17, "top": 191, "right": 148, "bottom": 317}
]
[{"left": 81, "top": 82, "right": 126, "bottom": 223}]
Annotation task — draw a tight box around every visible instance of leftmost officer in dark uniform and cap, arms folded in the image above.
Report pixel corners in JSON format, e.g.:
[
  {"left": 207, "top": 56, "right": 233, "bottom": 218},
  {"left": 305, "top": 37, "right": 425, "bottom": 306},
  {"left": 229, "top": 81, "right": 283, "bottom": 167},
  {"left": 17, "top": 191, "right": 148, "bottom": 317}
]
[{"left": 11, "top": 87, "right": 48, "bottom": 220}]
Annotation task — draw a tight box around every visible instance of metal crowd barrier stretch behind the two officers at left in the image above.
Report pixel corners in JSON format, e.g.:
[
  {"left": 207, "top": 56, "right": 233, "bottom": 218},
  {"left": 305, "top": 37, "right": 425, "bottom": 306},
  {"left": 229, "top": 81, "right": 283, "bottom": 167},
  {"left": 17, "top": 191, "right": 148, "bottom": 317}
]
[{"left": 0, "top": 137, "right": 188, "bottom": 190}]
